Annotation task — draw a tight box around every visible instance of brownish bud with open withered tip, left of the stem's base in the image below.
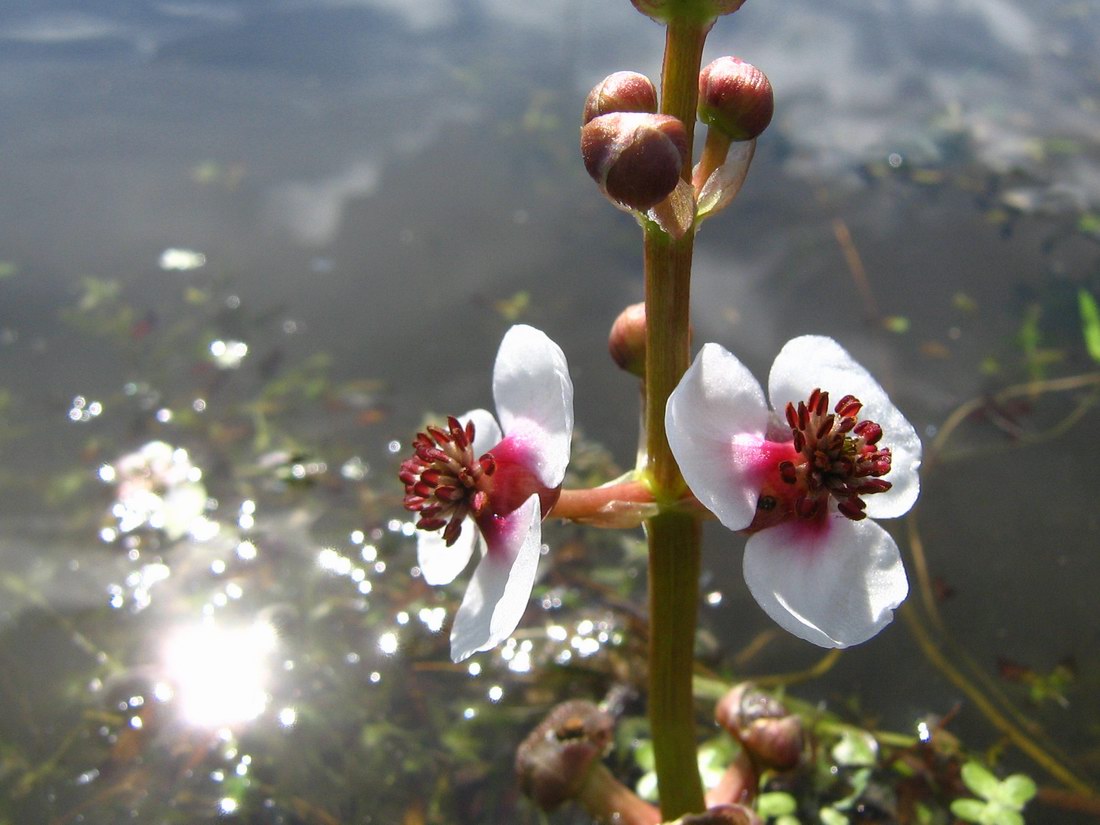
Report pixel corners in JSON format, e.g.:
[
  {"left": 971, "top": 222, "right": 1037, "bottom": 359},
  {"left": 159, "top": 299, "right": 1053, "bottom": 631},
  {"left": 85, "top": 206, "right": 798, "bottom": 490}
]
[{"left": 516, "top": 700, "right": 614, "bottom": 811}]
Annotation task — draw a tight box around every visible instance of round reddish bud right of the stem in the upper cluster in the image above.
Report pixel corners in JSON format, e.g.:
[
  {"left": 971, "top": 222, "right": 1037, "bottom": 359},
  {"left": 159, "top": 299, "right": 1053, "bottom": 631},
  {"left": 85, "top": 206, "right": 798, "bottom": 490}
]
[{"left": 699, "top": 57, "right": 776, "bottom": 141}]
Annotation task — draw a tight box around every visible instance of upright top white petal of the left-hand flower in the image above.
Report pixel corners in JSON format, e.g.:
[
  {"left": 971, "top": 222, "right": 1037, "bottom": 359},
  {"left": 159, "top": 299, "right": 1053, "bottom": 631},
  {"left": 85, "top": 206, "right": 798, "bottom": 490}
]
[{"left": 493, "top": 325, "right": 573, "bottom": 487}]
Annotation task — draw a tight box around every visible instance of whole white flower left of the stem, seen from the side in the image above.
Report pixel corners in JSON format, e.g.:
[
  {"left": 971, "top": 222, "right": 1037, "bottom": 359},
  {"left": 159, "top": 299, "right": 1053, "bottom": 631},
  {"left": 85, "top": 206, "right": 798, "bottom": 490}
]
[{"left": 400, "top": 325, "right": 573, "bottom": 662}]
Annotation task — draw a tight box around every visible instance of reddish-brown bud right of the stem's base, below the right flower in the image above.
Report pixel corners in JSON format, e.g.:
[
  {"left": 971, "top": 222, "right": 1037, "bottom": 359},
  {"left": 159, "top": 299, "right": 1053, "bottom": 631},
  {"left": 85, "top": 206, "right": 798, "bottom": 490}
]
[{"left": 714, "top": 682, "right": 802, "bottom": 770}]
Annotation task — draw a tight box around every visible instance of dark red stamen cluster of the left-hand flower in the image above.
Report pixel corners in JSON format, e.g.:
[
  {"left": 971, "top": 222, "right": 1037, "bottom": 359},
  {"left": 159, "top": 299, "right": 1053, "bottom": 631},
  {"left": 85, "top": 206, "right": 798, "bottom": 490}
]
[{"left": 398, "top": 416, "right": 496, "bottom": 547}]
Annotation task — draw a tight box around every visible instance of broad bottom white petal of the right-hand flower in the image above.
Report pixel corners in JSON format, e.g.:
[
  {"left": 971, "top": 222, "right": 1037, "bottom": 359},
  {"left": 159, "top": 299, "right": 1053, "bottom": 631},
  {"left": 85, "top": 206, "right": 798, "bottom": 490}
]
[{"left": 745, "top": 513, "right": 909, "bottom": 648}]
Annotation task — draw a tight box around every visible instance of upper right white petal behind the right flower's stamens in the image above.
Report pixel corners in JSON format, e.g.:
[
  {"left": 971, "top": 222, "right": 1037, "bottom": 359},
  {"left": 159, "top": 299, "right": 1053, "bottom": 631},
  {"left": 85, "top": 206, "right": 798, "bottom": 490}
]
[{"left": 768, "top": 336, "right": 921, "bottom": 518}]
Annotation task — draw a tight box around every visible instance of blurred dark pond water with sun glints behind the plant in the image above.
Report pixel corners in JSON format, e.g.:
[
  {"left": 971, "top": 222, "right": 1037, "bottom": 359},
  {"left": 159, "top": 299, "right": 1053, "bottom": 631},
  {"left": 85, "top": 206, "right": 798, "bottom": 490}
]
[{"left": 0, "top": 0, "right": 1100, "bottom": 824}]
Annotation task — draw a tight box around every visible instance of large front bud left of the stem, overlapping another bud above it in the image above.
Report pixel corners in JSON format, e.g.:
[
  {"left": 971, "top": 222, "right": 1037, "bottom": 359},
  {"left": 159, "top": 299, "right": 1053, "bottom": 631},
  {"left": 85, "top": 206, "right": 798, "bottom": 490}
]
[{"left": 581, "top": 112, "right": 688, "bottom": 211}]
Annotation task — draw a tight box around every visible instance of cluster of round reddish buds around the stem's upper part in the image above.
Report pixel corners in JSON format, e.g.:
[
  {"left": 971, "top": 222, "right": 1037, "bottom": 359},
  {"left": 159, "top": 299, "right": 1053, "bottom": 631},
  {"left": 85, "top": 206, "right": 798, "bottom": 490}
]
[{"left": 581, "top": 55, "right": 774, "bottom": 238}]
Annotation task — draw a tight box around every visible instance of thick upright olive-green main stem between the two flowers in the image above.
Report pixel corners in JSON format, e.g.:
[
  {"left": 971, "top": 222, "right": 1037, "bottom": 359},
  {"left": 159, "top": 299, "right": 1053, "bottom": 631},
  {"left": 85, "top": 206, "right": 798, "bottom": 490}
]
[{"left": 645, "top": 21, "right": 711, "bottom": 820}]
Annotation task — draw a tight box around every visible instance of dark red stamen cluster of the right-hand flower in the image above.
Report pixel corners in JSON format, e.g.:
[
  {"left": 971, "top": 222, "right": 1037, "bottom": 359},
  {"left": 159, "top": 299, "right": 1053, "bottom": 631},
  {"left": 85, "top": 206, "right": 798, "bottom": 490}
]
[{"left": 779, "top": 389, "right": 892, "bottom": 521}]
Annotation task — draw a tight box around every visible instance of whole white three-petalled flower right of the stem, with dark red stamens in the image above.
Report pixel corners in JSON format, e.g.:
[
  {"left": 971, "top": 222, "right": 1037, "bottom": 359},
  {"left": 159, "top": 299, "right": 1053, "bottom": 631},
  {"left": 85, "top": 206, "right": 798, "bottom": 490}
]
[{"left": 666, "top": 336, "right": 921, "bottom": 648}]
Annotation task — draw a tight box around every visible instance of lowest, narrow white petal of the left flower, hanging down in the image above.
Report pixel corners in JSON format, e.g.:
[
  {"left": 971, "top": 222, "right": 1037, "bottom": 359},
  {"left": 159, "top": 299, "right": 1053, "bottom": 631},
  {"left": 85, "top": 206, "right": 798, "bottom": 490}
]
[{"left": 451, "top": 495, "right": 542, "bottom": 662}]
